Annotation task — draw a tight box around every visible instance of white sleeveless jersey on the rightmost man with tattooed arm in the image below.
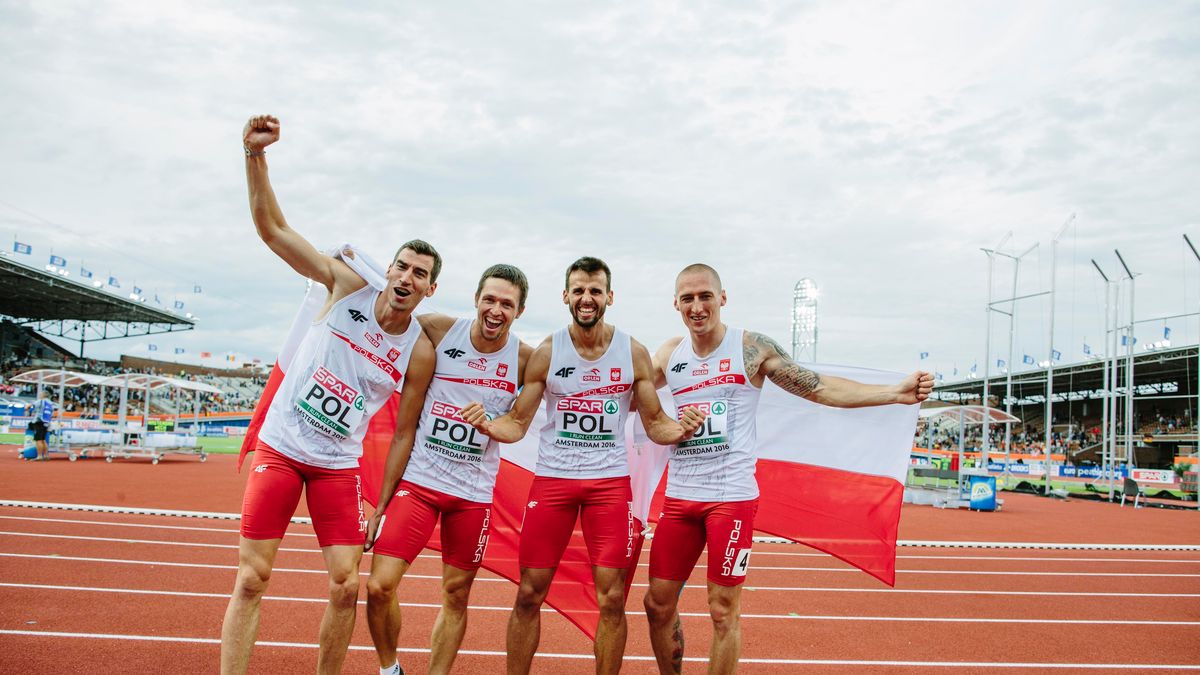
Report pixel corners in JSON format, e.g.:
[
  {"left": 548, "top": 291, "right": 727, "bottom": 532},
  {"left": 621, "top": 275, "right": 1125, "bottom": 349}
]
[{"left": 665, "top": 328, "right": 762, "bottom": 502}]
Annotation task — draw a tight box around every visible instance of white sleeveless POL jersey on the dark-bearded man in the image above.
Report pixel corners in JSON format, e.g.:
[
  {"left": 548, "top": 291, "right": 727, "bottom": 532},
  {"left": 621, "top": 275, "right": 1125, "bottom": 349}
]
[{"left": 535, "top": 328, "right": 634, "bottom": 478}]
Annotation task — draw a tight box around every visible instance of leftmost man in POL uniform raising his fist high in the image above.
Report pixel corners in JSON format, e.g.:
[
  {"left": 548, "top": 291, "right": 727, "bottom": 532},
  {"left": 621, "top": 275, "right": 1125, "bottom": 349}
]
[{"left": 221, "top": 115, "right": 442, "bottom": 673}]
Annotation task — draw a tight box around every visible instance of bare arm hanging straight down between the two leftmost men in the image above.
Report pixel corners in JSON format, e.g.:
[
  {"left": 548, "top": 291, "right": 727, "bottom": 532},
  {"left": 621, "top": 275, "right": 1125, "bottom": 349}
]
[{"left": 362, "top": 335, "right": 437, "bottom": 550}]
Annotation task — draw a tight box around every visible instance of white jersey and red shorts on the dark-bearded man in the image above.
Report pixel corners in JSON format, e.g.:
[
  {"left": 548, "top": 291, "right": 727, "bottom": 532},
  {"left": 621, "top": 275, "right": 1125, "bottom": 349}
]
[{"left": 520, "top": 328, "right": 634, "bottom": 568}]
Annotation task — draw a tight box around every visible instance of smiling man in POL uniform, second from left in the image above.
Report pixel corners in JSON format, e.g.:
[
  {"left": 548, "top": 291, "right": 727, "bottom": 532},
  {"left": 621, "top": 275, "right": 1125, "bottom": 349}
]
[{"left": 366, "top": 264, "right": 533, "bottom": 675}]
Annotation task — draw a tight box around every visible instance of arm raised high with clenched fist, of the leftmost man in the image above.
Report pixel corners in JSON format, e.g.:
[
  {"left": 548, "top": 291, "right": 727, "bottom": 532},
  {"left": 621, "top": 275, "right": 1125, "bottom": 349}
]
[{"left": 242, "top": 115, "right": 366, "bottom": 294}]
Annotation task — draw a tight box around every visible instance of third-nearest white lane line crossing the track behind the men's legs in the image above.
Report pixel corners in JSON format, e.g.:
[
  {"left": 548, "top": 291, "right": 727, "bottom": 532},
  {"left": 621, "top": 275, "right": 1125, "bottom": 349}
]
[{"left": 0, "top": 552, "right": 1200, "bottom": 598}]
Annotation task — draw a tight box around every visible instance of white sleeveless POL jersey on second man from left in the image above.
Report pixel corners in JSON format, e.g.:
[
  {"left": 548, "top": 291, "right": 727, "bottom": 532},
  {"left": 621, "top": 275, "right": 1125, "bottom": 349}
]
[{"left": 404, "top": 318, "right": 521, "bottom": 502}]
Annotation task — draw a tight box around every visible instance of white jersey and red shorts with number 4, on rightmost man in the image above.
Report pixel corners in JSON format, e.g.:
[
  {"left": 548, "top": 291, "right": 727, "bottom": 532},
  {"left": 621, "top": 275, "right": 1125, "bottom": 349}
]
[{"left": 650, "top": 328, "right": 762, "bottom": 586}]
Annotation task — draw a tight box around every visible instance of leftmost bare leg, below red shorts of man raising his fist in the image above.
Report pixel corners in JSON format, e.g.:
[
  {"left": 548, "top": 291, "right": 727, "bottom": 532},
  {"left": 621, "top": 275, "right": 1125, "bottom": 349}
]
[{"left": 221, "top": 537, "right": 282, "bottom": 675}]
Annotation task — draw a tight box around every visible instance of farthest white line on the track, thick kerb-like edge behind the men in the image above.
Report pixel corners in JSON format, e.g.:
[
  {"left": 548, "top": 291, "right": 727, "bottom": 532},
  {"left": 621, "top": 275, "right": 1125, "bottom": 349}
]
[{"left": 0, "top": 500, "right": 1200, "bottom": 551}]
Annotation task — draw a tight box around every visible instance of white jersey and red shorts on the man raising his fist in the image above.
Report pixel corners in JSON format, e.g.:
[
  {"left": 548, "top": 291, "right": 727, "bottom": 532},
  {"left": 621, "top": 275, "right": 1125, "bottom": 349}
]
[{"left": 241, "top": 286, "right": 421, "bottom": 546}]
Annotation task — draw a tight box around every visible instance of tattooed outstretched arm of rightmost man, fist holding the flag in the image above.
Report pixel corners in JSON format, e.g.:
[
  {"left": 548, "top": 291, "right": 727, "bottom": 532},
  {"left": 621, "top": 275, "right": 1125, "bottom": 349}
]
[{"left": 742, "top": 330, "right": 934, "bottom": 408}]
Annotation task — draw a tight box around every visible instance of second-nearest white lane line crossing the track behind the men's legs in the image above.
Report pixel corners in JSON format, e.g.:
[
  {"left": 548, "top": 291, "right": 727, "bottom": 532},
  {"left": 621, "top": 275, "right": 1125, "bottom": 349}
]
[{"left": 0, "top": 583, "right": 1200, "bottom": 626}]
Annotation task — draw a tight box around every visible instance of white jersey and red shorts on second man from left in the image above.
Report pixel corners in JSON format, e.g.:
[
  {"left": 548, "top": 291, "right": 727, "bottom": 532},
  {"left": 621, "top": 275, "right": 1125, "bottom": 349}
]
[{"left": 374, "top": 318, "right": 521, "bottom": 571}]
